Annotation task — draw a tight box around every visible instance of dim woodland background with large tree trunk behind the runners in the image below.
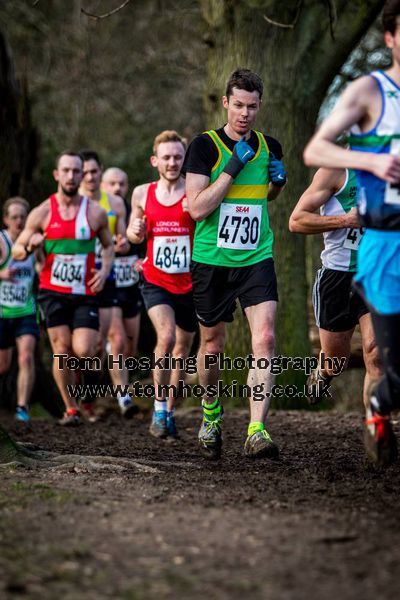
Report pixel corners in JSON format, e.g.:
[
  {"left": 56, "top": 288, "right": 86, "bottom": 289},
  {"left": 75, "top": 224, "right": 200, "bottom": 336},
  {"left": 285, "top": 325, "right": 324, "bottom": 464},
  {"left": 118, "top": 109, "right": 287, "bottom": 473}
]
[{"left": 0, "top": 0, "right": 388, "bottom": 410}]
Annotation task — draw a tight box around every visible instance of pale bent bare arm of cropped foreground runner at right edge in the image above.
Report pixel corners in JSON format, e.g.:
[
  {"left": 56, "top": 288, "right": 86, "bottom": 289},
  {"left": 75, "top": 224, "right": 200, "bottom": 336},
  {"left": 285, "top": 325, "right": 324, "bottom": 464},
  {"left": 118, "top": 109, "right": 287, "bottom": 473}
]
[{"left": 304, "top": 76, "right": 400, "bottom": 183}]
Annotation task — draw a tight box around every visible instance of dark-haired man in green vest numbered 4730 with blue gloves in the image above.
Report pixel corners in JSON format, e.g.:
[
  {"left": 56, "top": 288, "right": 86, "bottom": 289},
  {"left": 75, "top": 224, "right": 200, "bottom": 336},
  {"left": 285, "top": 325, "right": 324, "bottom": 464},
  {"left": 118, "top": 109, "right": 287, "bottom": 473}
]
[{"left": 183, "top": 69, "right": 286, "bottom": 459}]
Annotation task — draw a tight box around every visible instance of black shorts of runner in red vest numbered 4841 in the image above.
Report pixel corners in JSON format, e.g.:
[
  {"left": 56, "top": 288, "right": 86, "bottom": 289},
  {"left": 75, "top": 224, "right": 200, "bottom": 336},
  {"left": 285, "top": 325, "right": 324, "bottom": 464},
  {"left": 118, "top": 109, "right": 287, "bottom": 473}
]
[{"left": 140, "top": 277, "right": 197, "bottom": 333}]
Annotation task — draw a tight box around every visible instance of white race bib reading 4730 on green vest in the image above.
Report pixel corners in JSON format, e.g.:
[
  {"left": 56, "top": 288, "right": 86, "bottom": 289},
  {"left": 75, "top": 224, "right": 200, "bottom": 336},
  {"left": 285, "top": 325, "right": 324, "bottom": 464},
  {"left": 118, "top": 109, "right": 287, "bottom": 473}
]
[{"left": 217, "top": 204, "right": 262, "bottom": 250}]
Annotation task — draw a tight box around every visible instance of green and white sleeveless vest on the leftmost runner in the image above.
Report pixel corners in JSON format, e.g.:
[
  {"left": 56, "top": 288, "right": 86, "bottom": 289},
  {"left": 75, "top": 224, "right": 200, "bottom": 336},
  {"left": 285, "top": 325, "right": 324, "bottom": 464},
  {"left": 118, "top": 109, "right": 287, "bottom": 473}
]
[{"left": 0, "top": 229, "right": 36, "bottom": 319}]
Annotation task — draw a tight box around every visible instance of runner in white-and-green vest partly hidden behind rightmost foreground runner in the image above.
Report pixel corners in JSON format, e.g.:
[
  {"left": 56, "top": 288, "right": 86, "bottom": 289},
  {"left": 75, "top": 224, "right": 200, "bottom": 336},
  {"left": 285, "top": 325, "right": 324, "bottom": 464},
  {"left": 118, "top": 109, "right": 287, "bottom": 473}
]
[{"left": 289, "top": 169, "right": 381, "bottom": 407}]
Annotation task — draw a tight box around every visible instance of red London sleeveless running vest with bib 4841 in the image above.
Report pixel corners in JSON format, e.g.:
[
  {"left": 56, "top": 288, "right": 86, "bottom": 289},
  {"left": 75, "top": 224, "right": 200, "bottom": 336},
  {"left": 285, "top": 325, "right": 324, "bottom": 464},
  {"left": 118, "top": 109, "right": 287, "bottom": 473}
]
[{"left": 143, "top": 182, "right": 195, "bottom": 294}]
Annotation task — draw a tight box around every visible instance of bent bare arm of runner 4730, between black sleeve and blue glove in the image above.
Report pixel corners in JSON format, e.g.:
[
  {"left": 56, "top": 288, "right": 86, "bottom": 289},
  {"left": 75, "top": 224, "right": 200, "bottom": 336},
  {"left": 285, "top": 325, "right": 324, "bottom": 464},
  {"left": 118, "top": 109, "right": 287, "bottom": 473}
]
[{"left": 186, "top": 172, "right": 233, "bottom": 221}]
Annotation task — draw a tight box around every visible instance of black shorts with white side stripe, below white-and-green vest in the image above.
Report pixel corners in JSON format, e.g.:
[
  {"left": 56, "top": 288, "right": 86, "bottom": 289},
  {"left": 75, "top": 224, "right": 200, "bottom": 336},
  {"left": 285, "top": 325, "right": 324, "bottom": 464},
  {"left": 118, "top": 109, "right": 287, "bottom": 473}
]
[{"left": 313, "top": 267, "right": 369, "bottom": 332}]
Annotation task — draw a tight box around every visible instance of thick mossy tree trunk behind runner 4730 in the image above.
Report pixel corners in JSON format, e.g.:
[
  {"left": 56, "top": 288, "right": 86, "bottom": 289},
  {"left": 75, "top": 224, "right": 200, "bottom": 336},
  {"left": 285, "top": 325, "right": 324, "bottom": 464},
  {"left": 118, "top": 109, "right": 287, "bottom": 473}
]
[{"left": 200, "top": 0, "right": 383, "bottom": 398}]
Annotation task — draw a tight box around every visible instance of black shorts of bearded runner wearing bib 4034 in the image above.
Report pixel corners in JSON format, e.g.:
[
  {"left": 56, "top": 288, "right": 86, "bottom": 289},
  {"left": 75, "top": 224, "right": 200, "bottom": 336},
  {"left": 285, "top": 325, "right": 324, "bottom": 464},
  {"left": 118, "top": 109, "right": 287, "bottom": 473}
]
[{"left": 38, "top": 290, "right": 99, "bottom": 331}]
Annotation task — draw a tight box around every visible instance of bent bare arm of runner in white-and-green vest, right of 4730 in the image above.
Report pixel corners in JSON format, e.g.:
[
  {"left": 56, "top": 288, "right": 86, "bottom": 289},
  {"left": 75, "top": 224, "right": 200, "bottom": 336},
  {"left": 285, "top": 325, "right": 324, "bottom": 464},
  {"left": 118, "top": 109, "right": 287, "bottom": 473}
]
[{"left": 289, "top": 168, "right": 359, "bottom": 233}]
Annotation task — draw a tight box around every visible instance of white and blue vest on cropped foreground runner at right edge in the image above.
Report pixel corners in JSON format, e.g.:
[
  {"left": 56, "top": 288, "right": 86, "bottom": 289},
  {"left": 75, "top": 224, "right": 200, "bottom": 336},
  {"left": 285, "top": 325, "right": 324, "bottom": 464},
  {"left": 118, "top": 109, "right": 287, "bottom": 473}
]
[{"left": 349, "top": 71, "right": 400, "bottom": 230}]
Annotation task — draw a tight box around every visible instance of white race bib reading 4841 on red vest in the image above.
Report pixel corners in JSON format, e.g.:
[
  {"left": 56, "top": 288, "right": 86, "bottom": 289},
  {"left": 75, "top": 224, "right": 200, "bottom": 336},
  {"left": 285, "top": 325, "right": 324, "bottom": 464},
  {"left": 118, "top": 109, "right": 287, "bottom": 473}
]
[{"left": 153, "top": 235, "right": 190, "bottom": 275}]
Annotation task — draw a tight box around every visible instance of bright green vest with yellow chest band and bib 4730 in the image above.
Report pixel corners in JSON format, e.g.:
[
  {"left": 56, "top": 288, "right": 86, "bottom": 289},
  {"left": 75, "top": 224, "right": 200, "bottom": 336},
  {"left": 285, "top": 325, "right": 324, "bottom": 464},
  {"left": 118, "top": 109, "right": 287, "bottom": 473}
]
[{"left": 193, "top": 131, "right": 274, "bottom": 267}]
